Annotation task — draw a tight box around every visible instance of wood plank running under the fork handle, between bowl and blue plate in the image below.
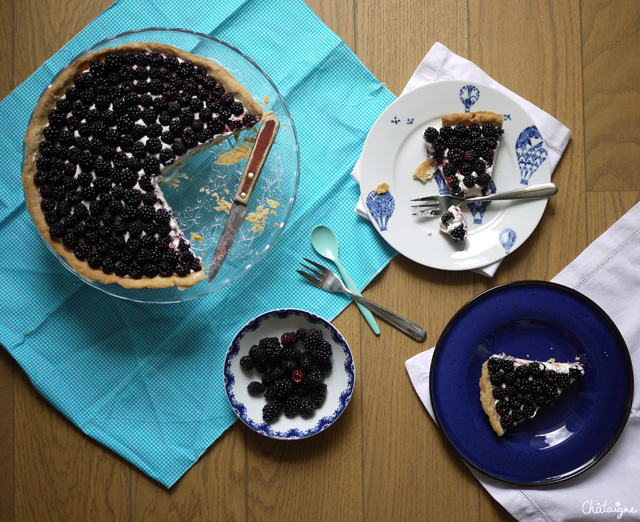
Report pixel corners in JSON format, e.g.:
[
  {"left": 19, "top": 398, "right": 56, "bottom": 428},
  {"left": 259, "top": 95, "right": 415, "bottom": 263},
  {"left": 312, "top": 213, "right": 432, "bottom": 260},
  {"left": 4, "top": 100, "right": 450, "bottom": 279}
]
[{"left": 356, "top": 0, "right": 477, "bottom": 520}]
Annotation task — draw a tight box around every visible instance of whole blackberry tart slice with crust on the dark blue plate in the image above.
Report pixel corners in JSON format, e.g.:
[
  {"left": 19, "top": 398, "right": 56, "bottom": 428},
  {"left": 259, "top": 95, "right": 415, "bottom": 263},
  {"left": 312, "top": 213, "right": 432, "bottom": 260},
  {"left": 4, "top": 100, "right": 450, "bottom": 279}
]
[{"left": 480, "top": 354, "right": 584, "bottom": 436}]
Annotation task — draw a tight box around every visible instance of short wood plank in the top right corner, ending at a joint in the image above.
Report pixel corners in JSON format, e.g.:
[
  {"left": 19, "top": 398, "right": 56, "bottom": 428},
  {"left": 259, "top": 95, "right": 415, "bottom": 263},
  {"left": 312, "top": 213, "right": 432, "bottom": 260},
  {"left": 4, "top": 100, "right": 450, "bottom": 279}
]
[{"left": 582, "top": 0, "right": 640, "bottom": 191}]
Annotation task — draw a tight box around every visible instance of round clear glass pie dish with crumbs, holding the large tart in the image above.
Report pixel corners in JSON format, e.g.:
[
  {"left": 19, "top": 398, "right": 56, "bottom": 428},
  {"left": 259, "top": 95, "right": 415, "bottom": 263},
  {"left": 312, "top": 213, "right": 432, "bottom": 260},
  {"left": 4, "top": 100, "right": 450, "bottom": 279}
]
[{"left": 23, "top": 28, "right": 300, "bottom": 303}]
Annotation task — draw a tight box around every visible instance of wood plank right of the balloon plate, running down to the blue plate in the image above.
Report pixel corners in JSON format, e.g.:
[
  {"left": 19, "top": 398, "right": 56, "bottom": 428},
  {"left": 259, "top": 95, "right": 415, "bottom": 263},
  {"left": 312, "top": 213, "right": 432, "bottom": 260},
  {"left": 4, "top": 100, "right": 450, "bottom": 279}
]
[{"left": 470, "top": 0, "right": 588, "bottom": 291}]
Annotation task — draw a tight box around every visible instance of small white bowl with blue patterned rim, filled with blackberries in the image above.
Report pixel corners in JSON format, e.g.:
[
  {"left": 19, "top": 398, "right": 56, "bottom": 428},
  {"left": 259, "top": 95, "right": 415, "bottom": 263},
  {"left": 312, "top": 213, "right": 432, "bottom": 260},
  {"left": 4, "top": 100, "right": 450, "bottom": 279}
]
[{"left": 224, "top": 309, "right": 355, "bottom": 440}]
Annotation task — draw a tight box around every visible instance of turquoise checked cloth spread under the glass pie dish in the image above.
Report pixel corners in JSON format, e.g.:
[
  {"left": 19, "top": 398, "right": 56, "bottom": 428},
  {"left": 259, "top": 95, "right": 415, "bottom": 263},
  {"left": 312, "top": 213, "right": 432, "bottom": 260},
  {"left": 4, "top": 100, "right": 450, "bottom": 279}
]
[{"left": 0, "top": 0, "right": 395, "bottom": 486}]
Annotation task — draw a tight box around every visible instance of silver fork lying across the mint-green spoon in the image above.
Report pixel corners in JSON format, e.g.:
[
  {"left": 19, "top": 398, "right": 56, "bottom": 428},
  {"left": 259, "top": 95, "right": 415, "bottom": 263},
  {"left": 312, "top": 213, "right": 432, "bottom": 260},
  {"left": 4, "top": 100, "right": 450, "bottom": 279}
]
[{"left": 296, "top": 258, "right": 427, "bottom": 342}]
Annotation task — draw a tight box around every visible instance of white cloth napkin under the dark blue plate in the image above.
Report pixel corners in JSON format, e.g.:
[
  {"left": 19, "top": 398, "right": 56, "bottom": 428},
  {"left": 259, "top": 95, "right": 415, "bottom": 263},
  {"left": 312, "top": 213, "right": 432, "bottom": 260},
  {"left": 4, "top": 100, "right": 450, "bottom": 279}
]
[{"left": 405, "top": 203, "right": 640, "bottom": 522}]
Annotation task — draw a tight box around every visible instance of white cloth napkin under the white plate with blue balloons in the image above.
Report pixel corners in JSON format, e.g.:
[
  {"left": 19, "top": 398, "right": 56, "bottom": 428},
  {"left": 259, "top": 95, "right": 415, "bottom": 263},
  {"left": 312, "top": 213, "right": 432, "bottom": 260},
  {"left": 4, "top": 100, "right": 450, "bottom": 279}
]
[{"left": 351, "top": 42, "right": 571, "bottom": 277}]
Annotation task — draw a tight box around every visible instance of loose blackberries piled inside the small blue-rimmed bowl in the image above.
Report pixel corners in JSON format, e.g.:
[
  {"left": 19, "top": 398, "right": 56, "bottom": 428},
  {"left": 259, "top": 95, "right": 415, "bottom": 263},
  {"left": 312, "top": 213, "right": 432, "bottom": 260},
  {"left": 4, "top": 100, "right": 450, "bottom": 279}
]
[{"left": 240, "top": 328, "right": 333, "bottom": 424}]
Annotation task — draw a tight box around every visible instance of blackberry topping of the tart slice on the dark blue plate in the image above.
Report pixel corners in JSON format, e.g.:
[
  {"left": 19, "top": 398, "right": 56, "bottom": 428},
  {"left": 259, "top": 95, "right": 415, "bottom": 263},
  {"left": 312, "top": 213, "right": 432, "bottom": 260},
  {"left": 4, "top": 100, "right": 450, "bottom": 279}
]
[{"left": 487, "top": 357, "right": 582, "bottom": 430}]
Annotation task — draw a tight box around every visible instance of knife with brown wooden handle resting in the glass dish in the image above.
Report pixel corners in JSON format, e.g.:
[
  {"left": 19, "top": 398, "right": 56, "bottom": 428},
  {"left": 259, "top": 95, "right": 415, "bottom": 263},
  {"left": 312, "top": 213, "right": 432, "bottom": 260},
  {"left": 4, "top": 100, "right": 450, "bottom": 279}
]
[{"left": 208, "top": 114, "right": 280, "bottom": 282}]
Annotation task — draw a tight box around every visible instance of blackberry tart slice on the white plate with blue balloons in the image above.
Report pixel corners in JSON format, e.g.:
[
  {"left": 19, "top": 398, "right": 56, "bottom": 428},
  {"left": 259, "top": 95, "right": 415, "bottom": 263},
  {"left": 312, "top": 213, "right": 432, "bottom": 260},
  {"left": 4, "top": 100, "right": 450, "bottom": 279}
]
[{"left": 423, "top": 111, "right": 504, "bottom": 199}]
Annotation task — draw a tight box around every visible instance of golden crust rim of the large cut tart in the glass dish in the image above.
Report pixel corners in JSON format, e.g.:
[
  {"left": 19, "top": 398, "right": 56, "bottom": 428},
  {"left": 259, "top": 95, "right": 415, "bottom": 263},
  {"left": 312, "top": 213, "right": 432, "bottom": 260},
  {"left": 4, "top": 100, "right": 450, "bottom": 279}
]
[{"left": 22, "top": 42, "right": 263, "bottom": 289}]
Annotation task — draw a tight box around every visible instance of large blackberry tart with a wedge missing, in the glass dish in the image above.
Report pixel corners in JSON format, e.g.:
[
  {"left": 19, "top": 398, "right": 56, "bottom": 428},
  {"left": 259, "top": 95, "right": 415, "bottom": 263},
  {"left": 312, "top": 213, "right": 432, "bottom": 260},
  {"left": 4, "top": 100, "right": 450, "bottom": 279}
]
[{"left": 22, "top": 42, "right": 263, "bottom": 289}]
